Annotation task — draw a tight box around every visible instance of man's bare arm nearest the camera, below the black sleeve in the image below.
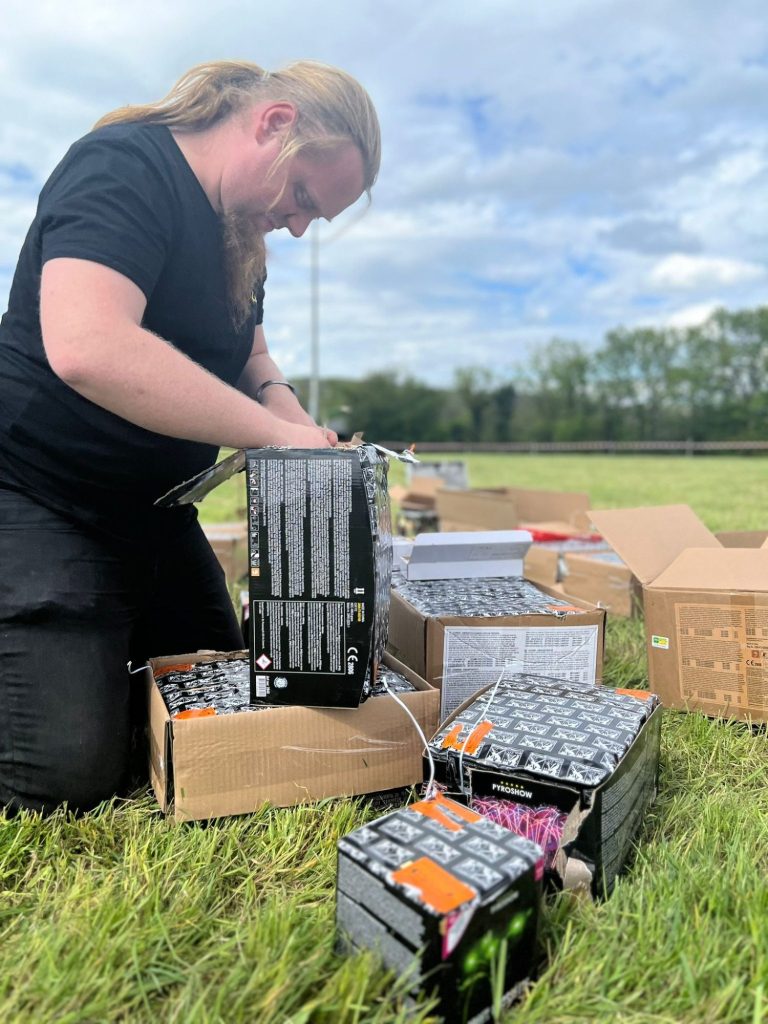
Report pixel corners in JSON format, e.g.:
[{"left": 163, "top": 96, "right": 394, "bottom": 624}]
[{"left": 40, "top": 259, "right": 328, "bottom": 447}]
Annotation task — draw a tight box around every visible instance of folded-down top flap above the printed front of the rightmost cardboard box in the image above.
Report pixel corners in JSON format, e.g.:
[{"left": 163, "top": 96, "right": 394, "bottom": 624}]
[{"left": 652, "top": 548, "right": 768, "bottom": 593}]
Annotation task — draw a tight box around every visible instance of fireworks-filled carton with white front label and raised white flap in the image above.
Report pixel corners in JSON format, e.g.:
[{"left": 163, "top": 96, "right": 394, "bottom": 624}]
[{"left": 388, "top": 530, "right": 605, "bottom": 718}]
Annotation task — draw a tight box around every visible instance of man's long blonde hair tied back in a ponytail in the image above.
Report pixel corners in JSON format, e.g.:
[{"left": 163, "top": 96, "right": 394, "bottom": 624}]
[{"left": 94, "top": 60, "right": 381, "bottom": 197}]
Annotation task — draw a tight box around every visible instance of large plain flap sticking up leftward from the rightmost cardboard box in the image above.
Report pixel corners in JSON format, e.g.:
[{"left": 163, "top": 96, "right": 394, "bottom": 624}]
[{"left": 590, "top": 505, "right": 722, "bottom": 584}]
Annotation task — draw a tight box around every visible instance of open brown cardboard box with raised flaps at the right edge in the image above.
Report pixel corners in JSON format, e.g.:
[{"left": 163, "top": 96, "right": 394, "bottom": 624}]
[{"left": 592, "top": 505, "right": 768, "bottom": 722}]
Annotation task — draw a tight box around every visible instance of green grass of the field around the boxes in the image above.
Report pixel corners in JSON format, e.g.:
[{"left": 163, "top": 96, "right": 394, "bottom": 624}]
[{"left": 0, "top": 456, "right": 768, "bottom": 1024}]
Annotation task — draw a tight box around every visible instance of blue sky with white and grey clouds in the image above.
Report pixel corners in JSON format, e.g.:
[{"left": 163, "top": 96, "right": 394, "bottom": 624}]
[{"left": 0, "top": 0, "right": 768, "bottom": 385}]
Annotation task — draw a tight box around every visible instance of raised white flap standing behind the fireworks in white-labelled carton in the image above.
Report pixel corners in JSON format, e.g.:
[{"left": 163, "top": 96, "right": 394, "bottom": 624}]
[{"left": 406, "top": 529, "right": 530, "bottom": 580}]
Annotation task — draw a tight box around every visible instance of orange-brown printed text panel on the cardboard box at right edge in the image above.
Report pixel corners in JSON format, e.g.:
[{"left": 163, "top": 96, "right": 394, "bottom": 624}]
[{"left": 675, "top": 604, "right": 768, "bottom": 714}]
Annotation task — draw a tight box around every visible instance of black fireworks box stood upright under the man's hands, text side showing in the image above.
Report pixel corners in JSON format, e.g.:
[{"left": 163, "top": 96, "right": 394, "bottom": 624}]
[{"left": 158, "top": 444, "right": 409, "bottom": 708}]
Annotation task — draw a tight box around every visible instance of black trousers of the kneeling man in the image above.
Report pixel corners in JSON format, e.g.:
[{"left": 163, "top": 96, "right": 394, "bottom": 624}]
[{"left": 0, "top": 488, "right": 243, "bottom": 811}]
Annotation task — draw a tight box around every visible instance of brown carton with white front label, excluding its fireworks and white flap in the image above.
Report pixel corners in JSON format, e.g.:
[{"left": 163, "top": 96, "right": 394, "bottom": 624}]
[{"left": 388, "top": 580, "right": 605, "bottom": 718}]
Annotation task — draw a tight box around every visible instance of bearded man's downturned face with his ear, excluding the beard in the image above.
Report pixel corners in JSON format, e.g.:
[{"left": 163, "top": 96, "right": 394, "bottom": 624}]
[{"left": 221, "top": 104, "right": 364, "bottom": 238}]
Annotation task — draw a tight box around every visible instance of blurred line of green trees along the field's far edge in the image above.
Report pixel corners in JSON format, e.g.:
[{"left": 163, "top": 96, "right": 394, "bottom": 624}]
[{"left": 300, "top": 306, "right": 768, "bottom": 441}]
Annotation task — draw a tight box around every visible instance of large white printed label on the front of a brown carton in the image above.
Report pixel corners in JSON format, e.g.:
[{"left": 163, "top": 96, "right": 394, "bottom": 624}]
[{"left": 440, "top": 626, "right": 599, "bottom": 719}]
